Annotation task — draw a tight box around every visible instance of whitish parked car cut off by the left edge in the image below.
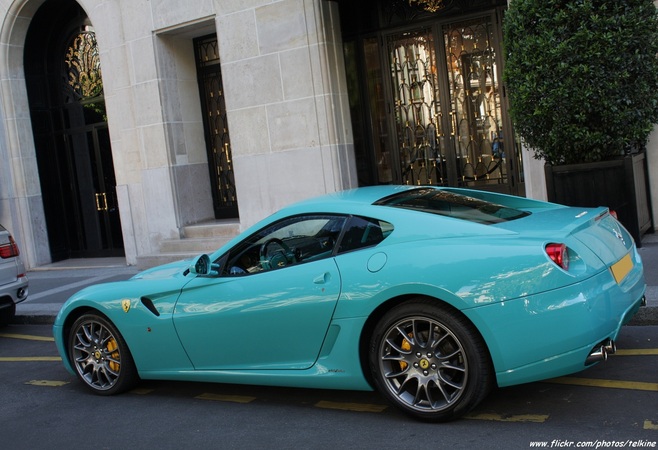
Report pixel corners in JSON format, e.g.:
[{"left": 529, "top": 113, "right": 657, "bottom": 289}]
[{"left": 0, "top": 225, "right": 28, "bottom": 327}]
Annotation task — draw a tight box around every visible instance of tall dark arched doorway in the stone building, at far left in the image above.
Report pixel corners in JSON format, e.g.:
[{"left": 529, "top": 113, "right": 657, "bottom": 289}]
[{"left": 24, "top": 0, "right": 124, "bottom": 261}]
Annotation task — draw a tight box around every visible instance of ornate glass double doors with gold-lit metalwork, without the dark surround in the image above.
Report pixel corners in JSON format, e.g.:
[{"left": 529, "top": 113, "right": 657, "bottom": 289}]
[{"left": 385, "top": 15, "right": 521, "bottom": 194}]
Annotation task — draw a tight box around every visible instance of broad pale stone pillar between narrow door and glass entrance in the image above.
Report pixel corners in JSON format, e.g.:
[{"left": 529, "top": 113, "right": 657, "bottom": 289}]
[{"left": 217, "top": 0, "right": 357, "bottom": 228}]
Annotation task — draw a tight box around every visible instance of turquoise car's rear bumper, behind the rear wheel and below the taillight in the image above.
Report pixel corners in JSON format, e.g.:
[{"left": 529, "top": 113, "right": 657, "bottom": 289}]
[{"left": 464, "top": 251, "right": 646, "bottom": 387}]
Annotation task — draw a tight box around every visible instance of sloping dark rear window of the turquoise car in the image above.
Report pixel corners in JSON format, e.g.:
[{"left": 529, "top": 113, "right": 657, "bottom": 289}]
[{"left": 375, "top": 188, "right": 530, "bottom": 225}]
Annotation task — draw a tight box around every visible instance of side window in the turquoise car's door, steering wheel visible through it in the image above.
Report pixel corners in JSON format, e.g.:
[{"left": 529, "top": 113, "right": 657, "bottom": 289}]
[{"left": 222, "top": 215, "right": 347, "bottom": 276}]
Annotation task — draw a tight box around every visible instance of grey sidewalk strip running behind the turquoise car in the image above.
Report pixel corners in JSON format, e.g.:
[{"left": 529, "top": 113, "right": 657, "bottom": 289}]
[{"left": 14, "top": 233, "right": 658, "bottom": 325}]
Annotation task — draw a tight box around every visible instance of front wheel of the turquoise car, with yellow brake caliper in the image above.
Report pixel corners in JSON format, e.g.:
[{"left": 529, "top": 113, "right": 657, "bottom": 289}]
[{"left": 68, "top": 313, "right": 139, "bottom": 395}]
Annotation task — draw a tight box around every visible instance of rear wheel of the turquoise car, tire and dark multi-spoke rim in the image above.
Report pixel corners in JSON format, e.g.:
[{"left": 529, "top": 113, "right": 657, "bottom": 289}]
[{"left": 369, "top": 298, "right": 493, "bottom": 422}]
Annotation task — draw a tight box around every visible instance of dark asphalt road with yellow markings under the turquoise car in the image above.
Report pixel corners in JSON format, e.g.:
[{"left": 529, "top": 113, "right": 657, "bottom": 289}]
[{"left": 0, "top": 325, "right": 658, "bottom": 450}]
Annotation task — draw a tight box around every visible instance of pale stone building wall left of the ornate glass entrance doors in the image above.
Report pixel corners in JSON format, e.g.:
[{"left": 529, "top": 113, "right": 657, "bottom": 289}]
[{"left": 0, "top": 0, "right": 357, "bottom": 267}]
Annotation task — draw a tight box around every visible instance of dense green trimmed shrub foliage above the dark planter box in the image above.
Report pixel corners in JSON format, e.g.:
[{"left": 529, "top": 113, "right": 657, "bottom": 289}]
[{"left": 503, "top": 0, "right": 658, "bottom": 165}]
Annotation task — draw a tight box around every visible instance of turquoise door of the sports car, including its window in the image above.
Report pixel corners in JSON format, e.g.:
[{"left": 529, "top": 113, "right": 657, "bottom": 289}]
[{"left": 174, "top": 216, "right": 344, "bottom": 370}]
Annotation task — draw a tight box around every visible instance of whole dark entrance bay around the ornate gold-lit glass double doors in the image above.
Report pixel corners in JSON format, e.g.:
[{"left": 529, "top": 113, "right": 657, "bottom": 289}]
[{"left": 340, "top": 0, "right": 524, "bottom": 195}]
